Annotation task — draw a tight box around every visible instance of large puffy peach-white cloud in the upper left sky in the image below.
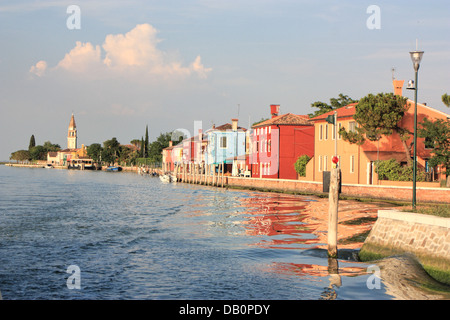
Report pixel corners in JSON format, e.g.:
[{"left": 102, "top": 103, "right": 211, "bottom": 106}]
[{"left": 30, "top": 24, "right": 212, "bottom": 79}]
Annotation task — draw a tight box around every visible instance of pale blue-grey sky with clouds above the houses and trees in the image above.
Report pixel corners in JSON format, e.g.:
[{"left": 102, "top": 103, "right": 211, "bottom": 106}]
[{"left": 0, "top": 0, "right": 450, "bottom": 160}]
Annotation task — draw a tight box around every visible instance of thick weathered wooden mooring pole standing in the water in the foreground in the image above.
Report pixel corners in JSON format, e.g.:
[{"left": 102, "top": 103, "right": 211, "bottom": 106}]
[{"left": 328, "top": 168, "right": 340, "bottom": 258}]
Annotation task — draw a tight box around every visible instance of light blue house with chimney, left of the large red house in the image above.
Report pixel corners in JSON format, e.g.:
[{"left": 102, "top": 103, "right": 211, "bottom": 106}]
[{"left": 205, "top": 119, "right": 246, "bottom": 174}]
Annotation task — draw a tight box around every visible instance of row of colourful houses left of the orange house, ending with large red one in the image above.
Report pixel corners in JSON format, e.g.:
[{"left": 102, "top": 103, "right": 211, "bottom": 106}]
[{"left": 162, "top": 105, "right": 314, "bottom": 179}]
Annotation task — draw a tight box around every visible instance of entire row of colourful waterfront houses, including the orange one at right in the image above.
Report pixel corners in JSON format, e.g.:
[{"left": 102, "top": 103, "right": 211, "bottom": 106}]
[{"left": 163, "top": 80, "right": 450, "bottom": 184}]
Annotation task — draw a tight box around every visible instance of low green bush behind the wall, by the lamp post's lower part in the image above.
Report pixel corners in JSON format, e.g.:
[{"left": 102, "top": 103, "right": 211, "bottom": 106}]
[{"left": 375, "top": 159, "right": 425, "bottom": 181}]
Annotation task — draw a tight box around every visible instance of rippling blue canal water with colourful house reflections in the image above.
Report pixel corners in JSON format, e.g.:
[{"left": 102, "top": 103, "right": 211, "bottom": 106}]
[{"left": 0, "top": 166, "right": 444, "bottom": 300}]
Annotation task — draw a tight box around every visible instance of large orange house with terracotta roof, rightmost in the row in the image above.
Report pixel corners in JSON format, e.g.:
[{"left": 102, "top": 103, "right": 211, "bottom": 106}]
[{"left": 306, "top": 80, "right": 450, "bottom": 184}]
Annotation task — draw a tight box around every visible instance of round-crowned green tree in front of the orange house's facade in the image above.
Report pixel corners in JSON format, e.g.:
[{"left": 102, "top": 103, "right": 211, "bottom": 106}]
[{"left": 339, "top": 93, "right": 411, "bottom": 165}]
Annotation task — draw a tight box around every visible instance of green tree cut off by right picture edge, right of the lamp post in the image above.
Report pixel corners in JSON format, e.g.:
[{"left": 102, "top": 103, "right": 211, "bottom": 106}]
[{"left": 417, "top": 118, "right": 450, "bottom": 187}]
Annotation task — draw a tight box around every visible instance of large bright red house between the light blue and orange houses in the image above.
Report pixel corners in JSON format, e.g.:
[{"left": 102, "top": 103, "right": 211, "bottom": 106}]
[{"left": 248, "top": 105, "right": 314, "bottom": 179}]
